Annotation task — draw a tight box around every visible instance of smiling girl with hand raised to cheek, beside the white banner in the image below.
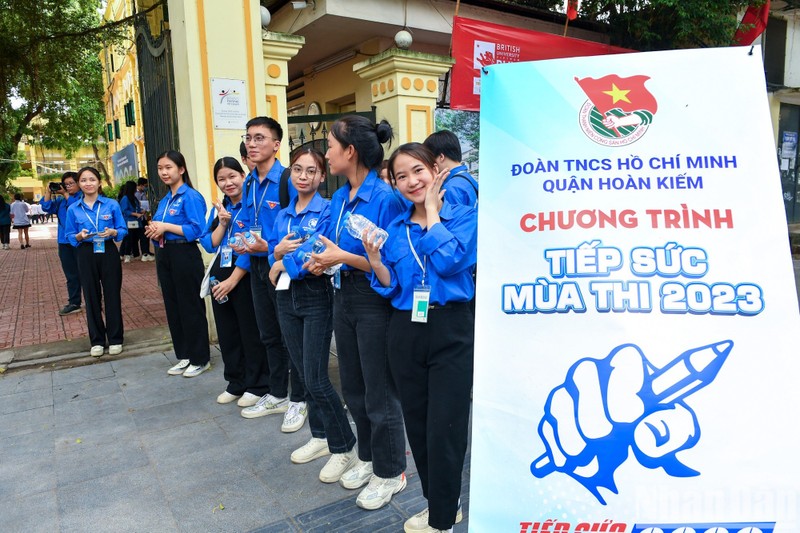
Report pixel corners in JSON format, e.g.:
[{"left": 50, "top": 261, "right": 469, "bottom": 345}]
[{"left": 364, "top": 143, "right": 478, "bottom": 531}]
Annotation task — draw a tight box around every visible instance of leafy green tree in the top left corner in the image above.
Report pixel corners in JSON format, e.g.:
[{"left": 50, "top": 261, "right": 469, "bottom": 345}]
[{"left": 0, "top": 0, "right": 163, "bottom": 189}]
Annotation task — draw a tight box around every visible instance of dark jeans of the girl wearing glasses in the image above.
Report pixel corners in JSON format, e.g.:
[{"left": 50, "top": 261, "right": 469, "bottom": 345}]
[{"left": 276, "top": 274, "right": 356, "bottom": 453}]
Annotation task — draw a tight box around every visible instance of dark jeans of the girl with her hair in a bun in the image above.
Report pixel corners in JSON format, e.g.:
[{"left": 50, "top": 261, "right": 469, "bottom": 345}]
[{"left": 333, "top": 271, "right": 406, "bottom": 478}]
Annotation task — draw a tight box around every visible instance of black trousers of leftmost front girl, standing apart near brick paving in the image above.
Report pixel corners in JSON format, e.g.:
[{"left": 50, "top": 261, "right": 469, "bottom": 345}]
[{"left": 75, "top": 239, "right": 124, "bottom": 346}]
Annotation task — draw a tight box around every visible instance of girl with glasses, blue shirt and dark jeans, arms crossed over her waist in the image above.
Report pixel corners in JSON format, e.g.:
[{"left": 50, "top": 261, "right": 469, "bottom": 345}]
[{"left": 269, "top": 148, "right": 357, "bottom": 483}]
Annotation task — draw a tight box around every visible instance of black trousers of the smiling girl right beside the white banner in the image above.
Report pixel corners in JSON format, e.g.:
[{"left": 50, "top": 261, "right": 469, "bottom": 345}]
[{"left": 389, "top": 303, "right": 474, "bottom": 529}]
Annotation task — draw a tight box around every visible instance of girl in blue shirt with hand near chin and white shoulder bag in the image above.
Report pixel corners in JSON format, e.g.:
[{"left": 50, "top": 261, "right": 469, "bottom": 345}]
[{"left": 200, "top": 157, "right": 265, "bottom": 404}]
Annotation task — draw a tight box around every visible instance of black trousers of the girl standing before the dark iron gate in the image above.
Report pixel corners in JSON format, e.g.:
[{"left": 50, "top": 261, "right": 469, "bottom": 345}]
[{"left": 156, "top": 242, "right": 211, "bottom": 365}]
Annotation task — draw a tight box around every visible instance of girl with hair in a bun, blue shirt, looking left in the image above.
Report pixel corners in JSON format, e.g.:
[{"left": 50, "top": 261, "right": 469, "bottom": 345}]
[{"left": 307, "top": 115, "right": 406, "bottom": 510}]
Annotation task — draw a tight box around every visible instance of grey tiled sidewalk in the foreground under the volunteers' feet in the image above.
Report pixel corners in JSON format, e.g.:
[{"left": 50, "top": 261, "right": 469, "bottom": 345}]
[{"left": 0, "top": 348, "right": 469, "bottom": 533}]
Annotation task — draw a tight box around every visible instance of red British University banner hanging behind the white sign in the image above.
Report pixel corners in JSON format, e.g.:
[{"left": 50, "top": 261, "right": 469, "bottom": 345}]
[{"left": 450, "top": 17, "right": 634, "bottom": 111}]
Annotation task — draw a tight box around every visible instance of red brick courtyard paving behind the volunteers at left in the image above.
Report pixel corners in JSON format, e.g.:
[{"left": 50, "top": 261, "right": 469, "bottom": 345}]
[{"left": 0, "top": 223, "right": 166, "bottom": 350}]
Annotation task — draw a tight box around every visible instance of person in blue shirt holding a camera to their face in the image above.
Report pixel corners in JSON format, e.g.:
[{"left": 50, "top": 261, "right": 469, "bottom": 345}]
[{"left": 42, "top": 171, "right": 82, "bottom": 316}]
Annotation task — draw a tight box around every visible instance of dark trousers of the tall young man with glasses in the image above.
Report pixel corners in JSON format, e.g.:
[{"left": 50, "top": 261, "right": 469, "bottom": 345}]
[{"left": 250, "top": 256, "right": 306, "bottom": 402}]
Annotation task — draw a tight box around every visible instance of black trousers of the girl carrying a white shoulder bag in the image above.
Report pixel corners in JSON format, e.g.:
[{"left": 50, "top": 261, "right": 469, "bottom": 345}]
[{"left": 211, "top": 255, "right": 267, "bottom": 396}]
